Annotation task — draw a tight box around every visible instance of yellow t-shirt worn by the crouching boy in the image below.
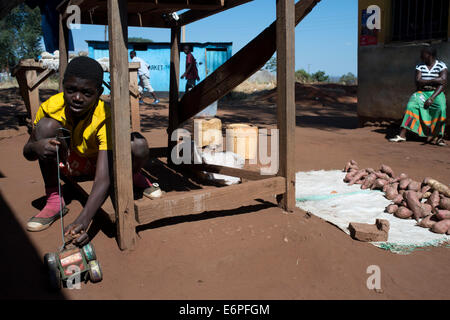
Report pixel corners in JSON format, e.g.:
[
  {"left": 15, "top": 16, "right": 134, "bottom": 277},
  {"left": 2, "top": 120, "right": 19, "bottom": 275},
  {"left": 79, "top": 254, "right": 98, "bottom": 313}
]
[{"left": 34, "top": 92, "right": 112, "bottom": 158}]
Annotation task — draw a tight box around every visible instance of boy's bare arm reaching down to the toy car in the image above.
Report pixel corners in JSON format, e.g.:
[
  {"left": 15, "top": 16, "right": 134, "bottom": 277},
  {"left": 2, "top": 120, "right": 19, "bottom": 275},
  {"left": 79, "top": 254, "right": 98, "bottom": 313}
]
[{"left": 65, "top": 150, "right": 112, "bottom": 246}]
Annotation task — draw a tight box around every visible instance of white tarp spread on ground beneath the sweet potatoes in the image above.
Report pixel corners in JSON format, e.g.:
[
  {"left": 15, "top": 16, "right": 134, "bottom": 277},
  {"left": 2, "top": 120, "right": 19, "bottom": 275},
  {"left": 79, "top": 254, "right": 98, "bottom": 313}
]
[{"left": 295, "top": 170, "right": 450, "bottom": 254}]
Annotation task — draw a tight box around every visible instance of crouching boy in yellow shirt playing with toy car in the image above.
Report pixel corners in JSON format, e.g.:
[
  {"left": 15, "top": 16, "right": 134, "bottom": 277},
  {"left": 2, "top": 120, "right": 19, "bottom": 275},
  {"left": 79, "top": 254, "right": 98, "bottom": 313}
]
[{"left": 23, "top": 57, "right": 161, "bottom": 246}]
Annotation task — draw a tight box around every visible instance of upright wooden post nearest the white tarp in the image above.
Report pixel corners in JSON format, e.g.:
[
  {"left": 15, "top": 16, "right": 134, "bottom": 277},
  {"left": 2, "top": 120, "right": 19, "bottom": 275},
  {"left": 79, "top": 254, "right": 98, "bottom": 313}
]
[{"left": 276, "top": 0, "right": 295, "bottom": 212}]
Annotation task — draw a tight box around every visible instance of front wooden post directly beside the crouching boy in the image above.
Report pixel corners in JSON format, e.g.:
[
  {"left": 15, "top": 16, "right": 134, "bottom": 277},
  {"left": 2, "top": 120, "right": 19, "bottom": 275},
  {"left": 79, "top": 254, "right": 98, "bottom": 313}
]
[{"left": 108, "top": 0, "right": 136, "bottom": 250}]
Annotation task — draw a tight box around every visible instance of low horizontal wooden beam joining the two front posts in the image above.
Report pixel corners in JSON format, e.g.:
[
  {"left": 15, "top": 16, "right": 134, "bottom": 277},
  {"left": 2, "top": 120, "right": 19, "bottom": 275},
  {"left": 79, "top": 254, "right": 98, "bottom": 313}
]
[{"left": 135, "top": 177, "right": 286, "bottom": 224}]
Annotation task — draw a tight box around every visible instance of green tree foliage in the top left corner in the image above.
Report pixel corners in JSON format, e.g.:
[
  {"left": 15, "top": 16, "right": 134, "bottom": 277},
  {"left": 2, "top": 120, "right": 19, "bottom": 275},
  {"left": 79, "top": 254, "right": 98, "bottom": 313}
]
[{"left": 0, "top": 4, "right": 42, "bottom": 69}]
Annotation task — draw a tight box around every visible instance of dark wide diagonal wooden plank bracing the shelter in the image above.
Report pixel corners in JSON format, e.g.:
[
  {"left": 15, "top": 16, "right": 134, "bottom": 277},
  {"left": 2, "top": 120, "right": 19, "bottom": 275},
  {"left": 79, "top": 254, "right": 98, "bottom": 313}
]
[{"left": 178, "top": 0, "right": 320, "bottom": 125}]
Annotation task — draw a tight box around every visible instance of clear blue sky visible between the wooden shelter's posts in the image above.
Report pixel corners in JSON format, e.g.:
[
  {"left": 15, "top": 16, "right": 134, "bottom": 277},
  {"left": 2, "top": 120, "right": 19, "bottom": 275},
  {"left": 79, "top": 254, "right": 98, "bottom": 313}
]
[{"left": 68, "top": 0, "right": 358, "bottom": 76}]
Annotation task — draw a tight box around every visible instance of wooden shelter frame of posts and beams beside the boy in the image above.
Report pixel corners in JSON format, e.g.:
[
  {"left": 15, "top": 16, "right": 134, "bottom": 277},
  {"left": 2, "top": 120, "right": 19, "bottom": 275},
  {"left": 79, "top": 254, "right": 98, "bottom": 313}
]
[{"left": 8, "top": 0, "right": 320, "bottom": 250}]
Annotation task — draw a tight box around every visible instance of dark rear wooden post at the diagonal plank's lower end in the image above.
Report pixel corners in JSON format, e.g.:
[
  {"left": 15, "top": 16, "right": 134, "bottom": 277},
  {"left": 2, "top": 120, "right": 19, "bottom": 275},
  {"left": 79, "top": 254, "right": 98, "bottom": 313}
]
[{"left": 167, "top": 27, "right": 180, "bottom": 163}]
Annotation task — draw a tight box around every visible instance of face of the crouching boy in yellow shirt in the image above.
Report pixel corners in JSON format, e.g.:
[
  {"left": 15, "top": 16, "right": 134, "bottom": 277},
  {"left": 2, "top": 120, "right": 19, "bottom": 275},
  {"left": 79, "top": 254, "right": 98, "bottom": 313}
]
[{"left": 64, "top": 76, "right": 103, "bottom": 118}]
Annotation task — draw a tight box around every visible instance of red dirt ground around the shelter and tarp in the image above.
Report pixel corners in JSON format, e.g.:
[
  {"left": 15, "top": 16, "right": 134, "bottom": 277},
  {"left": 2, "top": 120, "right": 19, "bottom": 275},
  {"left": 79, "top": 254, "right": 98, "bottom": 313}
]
[{"left": 0, "top": 84, "right": 450, "bottom": 300}]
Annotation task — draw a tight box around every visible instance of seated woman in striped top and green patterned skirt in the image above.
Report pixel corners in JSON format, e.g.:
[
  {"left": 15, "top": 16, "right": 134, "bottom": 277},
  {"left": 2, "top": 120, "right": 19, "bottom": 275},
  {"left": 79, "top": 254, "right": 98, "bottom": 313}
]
[{"left": 389, "top": 47, "right": 447, "bottom": 146}]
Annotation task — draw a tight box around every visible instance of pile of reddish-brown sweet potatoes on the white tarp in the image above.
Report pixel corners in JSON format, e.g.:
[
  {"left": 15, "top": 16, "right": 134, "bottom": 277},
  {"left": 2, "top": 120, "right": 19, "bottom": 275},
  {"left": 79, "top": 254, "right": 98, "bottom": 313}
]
[{"left": 344, "top": 160, "right": 450, "bottom": 234}]
